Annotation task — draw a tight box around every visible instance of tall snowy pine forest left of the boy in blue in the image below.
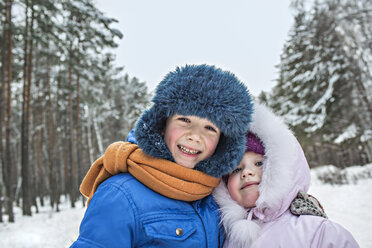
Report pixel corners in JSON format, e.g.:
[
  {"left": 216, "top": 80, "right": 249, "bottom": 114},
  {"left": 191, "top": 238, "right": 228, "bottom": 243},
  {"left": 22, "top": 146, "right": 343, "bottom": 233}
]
[{"left": 0, "top": 0, "right": 149, "bottom": 222}]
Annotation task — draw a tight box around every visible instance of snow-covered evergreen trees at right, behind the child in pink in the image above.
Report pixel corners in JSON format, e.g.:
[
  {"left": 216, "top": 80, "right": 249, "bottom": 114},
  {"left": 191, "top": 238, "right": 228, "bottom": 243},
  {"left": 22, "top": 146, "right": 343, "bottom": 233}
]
[{"left": 269, "top": 0, "right": 372, "bottom": 167}]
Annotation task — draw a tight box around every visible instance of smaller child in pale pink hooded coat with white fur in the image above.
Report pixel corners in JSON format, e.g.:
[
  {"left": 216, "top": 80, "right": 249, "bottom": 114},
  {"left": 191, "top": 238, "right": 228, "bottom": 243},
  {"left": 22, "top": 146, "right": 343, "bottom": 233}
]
[{"left": 213, "top": 103, "right": 359, "bottom": 248}]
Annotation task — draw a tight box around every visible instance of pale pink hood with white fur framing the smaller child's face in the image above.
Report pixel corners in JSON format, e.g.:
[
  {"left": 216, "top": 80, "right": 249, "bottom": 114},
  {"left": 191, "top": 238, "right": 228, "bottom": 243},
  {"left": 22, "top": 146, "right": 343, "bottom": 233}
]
[{"left": 213, "top": 103, "right": 310, "bottom": 247}]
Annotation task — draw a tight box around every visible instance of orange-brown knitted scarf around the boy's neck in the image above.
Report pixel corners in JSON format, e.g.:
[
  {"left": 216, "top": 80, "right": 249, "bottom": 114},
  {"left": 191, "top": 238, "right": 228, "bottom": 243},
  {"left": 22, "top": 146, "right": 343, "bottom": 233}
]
[{"left": 80, "top": 142, "right": 220, "bottom": 204}]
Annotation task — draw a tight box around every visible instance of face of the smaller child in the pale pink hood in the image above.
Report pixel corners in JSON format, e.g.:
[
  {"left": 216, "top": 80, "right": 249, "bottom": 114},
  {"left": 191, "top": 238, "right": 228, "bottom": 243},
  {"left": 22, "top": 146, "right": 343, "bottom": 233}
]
[{"left": 227, "top": 152, "right": 263, "bottom": 208}]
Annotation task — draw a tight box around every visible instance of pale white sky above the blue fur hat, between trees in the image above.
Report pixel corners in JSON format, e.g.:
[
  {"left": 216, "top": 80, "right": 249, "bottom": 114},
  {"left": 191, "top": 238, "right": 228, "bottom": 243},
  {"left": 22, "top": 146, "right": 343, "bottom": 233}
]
[{"left": 95, "top": 0, "right": 293, "bottom": 95}]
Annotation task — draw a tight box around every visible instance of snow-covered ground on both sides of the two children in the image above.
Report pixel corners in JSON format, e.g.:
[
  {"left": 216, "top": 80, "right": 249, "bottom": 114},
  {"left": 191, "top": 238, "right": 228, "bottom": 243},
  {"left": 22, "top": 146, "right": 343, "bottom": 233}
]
[{"left": 0, "top": 164, "right": 372, "bottom": 248}]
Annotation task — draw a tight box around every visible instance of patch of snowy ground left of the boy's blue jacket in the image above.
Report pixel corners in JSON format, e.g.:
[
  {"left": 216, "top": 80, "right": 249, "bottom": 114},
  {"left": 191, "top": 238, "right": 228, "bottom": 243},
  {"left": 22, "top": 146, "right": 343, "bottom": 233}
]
[{"left": 0, "top": 198, "right": 85, "bottom": 248}]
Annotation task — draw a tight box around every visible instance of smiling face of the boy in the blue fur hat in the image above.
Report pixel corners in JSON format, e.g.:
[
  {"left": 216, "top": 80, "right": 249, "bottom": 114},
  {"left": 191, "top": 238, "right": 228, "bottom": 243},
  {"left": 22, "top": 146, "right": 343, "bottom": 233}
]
[{"left": 164, "top": 114, "right": 221, "bottom": 169}]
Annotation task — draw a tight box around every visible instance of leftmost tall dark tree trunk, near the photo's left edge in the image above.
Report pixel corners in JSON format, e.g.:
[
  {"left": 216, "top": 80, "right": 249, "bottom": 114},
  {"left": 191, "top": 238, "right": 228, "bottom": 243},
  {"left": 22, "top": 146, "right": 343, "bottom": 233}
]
[{"left": 3, "top": 0, "right": 14, "bottom": 222}]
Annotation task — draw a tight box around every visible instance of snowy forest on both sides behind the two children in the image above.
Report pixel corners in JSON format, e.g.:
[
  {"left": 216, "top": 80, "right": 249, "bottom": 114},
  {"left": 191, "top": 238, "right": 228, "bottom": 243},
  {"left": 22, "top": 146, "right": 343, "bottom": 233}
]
[{"left": 0, "top": 0, "right": 372, "bottom": 222}]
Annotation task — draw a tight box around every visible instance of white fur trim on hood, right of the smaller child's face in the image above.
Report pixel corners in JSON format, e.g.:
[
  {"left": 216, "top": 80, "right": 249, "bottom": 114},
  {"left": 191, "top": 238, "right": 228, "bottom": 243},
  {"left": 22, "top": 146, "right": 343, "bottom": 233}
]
[{"left": 249, "top": 103, "right": 297, "bottom": 220}]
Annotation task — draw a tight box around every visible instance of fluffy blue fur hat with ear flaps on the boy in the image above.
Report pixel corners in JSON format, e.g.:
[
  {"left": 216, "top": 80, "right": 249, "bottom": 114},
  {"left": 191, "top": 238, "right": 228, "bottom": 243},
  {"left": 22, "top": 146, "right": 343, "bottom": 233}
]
[{"left": 135, "top": 65, "right": 253, "bottom": 177}]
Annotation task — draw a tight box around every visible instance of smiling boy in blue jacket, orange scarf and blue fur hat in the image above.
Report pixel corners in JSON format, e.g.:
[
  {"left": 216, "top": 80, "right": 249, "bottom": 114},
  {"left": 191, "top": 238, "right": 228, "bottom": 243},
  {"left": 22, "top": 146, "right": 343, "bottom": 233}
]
[{"left": 72, "top": 65, "right": 252, "bottom": 248}]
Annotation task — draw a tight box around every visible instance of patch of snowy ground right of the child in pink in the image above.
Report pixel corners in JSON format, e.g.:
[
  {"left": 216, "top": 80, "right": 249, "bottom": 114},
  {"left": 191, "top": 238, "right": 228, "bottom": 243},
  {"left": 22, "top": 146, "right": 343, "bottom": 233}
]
[{"left": 309, "top": 164, "right": 372, "bottom": 247}]
